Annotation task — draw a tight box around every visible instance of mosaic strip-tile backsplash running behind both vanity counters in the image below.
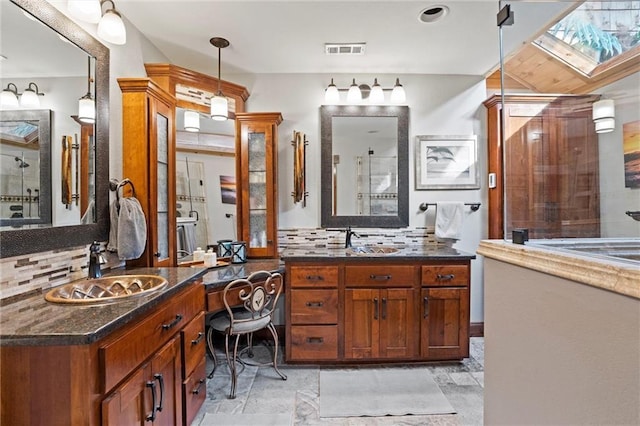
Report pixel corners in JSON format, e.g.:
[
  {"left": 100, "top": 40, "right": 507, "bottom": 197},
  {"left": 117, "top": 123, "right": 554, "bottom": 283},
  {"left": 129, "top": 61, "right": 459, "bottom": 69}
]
[{"left": 0, "top": 227, "right": 443, "bottom": 303}]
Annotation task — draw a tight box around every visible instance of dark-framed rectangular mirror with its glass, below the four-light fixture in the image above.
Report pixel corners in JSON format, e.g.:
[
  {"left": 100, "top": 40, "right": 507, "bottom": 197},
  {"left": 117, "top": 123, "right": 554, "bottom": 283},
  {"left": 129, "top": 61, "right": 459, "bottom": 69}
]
[{"left": 320, "top": 105, "right": 409, "bottom": 228}]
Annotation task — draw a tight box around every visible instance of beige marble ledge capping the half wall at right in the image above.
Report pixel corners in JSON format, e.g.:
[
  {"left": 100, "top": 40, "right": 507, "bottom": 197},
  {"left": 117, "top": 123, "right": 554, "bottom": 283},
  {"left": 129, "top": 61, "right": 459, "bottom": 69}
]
[{"left": 477, "top": 240, "right": 640, "bottom": 299}]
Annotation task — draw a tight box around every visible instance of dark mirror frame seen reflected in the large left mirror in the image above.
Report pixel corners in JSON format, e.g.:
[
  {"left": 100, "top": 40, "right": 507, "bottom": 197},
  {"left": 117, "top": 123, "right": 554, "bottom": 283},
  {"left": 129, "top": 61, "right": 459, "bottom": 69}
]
[{"left": 0, "top": 109, "right": 52, "bottom": 226}]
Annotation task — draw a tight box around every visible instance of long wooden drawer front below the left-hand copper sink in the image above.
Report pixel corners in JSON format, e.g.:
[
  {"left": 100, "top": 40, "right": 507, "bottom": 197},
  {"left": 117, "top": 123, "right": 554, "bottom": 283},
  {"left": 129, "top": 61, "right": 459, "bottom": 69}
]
[{"left": 99, "top": 283, "right": 204, "bottom": 392}]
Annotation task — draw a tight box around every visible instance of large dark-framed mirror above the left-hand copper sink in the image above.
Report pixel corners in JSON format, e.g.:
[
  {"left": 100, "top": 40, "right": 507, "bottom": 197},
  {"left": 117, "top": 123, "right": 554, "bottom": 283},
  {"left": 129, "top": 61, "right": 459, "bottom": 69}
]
[{"left": 0, "top": 0, "right": 109, "bottom": 258}]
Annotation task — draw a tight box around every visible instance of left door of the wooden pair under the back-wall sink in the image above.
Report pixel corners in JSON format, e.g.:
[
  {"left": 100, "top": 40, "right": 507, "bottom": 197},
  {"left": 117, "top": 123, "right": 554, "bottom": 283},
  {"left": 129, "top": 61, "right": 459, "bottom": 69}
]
[{"left": 344, "top": 289, "right": 380, "bottom": 359}]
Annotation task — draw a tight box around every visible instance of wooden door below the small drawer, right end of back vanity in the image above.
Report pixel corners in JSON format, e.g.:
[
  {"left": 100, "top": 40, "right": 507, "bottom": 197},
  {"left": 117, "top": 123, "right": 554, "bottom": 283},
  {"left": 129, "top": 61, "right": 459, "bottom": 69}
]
[{"left": 420, "top": 288, "right": 469, "bottom": 360}]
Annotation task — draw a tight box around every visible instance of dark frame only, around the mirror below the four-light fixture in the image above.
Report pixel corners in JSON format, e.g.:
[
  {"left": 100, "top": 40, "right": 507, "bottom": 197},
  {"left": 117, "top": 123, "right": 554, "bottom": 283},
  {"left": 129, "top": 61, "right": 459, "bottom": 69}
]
[{"left": 320, "top": 105, "right": 409, "bottom": 228}]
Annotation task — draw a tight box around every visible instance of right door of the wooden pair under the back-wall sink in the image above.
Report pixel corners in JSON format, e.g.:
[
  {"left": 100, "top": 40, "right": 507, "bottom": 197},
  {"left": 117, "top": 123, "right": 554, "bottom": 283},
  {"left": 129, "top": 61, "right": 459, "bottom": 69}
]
[{"left": 379, "top": 288, "right": 418, "bottom": 359}]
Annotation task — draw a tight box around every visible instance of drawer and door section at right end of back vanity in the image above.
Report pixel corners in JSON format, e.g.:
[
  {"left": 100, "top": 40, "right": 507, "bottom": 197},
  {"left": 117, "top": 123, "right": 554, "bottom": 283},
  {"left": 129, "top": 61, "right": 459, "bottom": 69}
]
[{"left": 420, "top": 264, "right": 470, "bottom": 360}]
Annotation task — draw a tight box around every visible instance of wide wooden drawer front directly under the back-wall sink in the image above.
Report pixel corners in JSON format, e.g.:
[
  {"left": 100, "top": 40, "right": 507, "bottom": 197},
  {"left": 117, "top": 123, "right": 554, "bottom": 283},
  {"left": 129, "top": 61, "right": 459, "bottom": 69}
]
[{"left": 345, "top": 265, "right": 416, "bottom": 287}]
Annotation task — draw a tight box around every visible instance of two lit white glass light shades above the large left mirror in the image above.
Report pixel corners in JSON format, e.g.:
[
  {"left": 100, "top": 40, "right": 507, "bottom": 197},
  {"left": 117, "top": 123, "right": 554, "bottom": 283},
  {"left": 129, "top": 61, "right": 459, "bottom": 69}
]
[{"left": 67, "top": 0, "right": 127, "bottom": 45}]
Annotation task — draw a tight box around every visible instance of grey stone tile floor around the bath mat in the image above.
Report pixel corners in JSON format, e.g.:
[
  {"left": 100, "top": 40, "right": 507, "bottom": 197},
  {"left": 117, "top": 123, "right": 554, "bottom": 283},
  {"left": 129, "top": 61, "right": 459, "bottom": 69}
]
[{"left": 192, "top": 337, "right": 484, "bottom": 426}]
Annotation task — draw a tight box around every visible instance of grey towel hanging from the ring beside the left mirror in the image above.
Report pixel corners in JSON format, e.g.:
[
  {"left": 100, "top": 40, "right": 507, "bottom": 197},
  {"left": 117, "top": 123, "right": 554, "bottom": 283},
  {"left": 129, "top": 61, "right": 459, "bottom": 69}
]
[{"left": 117, "top": 197, "right": 147, "bottom": 260}]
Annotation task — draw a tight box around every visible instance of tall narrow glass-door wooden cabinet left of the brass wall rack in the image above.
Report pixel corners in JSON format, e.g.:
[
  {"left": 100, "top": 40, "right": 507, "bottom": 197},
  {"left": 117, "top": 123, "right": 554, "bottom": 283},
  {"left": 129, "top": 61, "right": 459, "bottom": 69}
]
[{"left": 236, "top": 112, "right": 282, "bottom": 258}]
